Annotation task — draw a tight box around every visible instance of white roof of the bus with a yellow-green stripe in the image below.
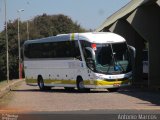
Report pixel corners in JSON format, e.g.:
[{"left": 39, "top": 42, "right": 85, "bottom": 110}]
[{"left": 24, "top": 32, "right": 125, "bottom": 44}]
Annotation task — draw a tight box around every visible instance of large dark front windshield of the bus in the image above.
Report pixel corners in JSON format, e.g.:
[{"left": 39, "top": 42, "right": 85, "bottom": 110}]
[{"left": 85, "top": 42, "right": 131, "bottom": 74}]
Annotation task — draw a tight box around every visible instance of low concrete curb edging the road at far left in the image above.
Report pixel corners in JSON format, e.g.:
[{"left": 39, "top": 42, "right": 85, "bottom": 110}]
[{"left": 0, "top": 79, "right": 24, "bottom": 98}]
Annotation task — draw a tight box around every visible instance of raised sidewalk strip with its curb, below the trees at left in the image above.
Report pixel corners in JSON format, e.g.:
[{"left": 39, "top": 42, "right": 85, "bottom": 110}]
[{"left": 0, "top": 79, "right": 24, "bottom": 98}]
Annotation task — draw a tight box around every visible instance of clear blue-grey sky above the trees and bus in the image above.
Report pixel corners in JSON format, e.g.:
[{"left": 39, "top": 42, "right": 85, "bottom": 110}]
[{"left": 0, "top": 0, "right": 130, "bottom": 31}]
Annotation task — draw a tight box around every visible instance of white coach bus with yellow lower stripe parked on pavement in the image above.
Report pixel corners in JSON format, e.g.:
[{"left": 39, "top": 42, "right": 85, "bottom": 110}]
[{"left": 24, "top": 32, "right": 134, "bottom": 91}]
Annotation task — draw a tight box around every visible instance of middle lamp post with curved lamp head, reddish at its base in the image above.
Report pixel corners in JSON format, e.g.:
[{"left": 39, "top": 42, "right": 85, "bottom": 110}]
[{"left": 17, "top": 9, "right": 24, "bottom": 79}]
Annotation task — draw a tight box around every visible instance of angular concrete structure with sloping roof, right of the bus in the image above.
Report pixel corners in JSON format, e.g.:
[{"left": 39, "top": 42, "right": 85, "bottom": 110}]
[{"left": 96, "top": 0, "right": 160, "bottom": 88}]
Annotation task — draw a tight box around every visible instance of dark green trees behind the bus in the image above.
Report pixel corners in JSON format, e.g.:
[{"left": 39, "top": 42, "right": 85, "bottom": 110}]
[{"left": 0, "top": 14, "right": 86, "bottom": 80}]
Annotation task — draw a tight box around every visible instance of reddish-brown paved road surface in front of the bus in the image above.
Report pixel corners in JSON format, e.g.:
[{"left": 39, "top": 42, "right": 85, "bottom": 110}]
[{"left": 0, "top": 82, "right": 160, "bottom": 114}]
